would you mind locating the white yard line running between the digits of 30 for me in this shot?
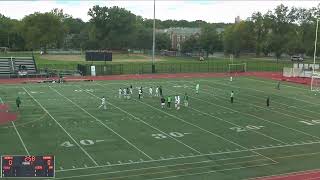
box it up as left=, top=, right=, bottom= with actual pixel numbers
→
left=81, top=83, right=201, bottom=154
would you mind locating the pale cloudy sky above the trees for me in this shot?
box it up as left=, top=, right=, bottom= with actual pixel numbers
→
left=0, top=0, right=319, bottom=23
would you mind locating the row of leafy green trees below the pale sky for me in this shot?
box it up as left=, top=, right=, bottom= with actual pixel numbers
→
left=0, top=4, right=320, bottom=58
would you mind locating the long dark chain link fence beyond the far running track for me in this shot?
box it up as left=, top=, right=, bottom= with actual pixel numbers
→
left=77, top=61, right=292, bottom=76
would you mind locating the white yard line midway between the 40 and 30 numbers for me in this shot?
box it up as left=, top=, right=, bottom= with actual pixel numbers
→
left=49, top=86, right=153, bottom=159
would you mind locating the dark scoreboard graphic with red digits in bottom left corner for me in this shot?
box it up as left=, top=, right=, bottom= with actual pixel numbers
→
left=1, top=155, right=55, bottom=178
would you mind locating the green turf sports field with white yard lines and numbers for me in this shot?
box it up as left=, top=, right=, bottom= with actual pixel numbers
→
left=0, top=77, right=320, bottom=180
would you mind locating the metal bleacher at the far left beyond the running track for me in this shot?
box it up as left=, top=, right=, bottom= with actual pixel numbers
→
left=0, top=57, right=37, bottom=77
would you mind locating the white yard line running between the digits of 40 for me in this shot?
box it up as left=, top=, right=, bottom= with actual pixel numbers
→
left=23, top=87, right=99, bottom=166
